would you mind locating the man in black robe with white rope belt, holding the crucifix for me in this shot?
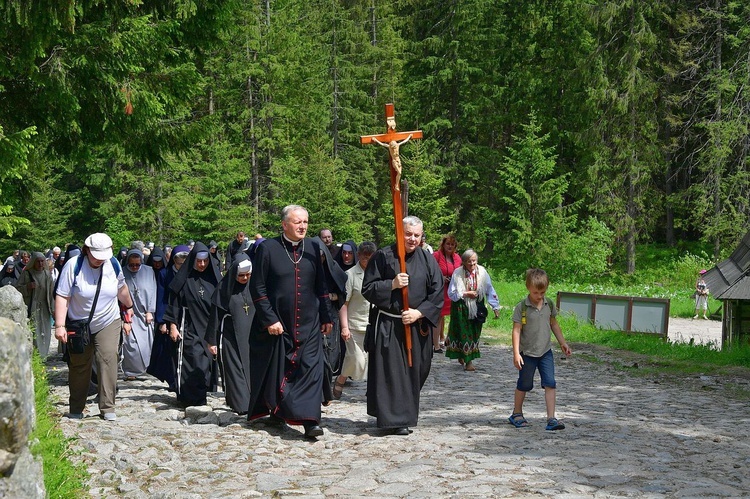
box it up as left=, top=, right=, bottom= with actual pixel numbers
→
left=362, top=217, right=443, bottom=435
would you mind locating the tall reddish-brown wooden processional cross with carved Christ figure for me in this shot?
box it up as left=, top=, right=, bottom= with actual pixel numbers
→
left=360, top=104, right=422, bottom=367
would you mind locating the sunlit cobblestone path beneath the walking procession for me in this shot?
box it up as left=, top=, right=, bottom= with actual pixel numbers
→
left=49, top=336, right=750, bottom=499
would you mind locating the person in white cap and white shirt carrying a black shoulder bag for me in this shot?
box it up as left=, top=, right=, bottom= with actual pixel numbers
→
left=55, top=233, right=133, bottom=421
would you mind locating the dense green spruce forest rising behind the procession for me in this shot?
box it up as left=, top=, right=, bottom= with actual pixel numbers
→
left=0, top=0, right=750, bottom=276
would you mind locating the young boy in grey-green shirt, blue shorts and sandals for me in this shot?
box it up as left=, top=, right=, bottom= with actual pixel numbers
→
left=508, top=269, right=572, bottom=430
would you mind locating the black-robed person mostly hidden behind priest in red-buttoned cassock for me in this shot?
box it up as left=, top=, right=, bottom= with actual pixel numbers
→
left=312, top=236, right=347, bottom=405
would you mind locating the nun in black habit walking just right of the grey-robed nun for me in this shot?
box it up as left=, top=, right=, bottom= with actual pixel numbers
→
left=164, top=242, right=221, bottom=405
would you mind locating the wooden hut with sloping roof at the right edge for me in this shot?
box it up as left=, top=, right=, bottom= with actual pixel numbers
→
left=703, top=232, right=750, bottom=345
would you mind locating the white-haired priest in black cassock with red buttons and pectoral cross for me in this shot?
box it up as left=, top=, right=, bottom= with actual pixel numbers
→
left=247, top=205, right=334, bottom=438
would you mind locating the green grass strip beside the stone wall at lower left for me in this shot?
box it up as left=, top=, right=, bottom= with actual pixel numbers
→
left=31, top=352, right=88, bottom=499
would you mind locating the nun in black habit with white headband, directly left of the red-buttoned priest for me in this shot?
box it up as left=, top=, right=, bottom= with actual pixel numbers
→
left=206, top=253, right=255, bottom=414
